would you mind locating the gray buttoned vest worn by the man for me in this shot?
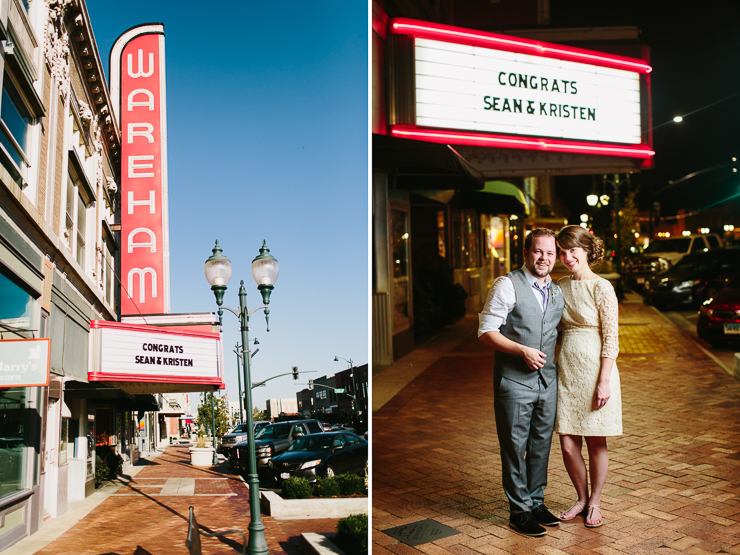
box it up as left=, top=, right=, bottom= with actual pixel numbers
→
left=493, top=268, right=565, bottom=387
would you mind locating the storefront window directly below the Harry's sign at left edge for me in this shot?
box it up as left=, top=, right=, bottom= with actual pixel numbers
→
left=0, top=387, right=33, bottom=498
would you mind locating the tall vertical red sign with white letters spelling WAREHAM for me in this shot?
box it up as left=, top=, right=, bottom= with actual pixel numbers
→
left=110, top=24, right=170, bottom=315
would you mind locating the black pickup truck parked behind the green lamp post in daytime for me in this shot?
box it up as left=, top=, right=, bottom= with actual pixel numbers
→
left=229, top=420, right=324, bottom=480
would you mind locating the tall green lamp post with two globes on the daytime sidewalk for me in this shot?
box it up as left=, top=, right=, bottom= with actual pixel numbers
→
left=205, top=241, right=278, bottom=555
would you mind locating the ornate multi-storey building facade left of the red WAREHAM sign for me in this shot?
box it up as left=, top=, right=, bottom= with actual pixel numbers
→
left=0, top=0, right=123, bottom=550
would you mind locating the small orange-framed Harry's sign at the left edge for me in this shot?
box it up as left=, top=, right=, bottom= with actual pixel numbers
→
left=0, top=338, right=51, bottom=389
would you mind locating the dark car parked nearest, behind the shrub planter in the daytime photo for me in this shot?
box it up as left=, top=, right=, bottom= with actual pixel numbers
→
left=271, top=431, right=368, bottom=482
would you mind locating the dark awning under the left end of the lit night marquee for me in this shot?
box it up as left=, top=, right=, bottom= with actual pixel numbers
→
left=373, top=134, right=483, bottom=190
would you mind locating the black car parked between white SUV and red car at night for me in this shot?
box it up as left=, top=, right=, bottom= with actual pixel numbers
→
left=643, top=249, right=740, bottom=306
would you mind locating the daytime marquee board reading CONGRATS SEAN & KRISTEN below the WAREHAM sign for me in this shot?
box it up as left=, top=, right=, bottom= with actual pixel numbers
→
left=88, top=320, right=223, bottom=386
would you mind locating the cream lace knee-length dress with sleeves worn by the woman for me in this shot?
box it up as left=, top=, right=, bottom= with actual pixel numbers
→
left=555, top=277, right=622, bottom=436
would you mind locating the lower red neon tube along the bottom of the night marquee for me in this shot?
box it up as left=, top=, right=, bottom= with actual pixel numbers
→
left=391, top=125, right=655, bottom=160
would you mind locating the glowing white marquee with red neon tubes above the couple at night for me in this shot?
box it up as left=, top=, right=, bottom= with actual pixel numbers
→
left=390, top=19, right=654, bottom=159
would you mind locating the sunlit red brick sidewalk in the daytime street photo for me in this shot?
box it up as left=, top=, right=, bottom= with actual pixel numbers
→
left=18, top=446, right=337, bottom=555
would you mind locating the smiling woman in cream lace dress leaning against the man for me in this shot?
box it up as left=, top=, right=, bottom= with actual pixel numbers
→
left=555, top=225, right=622, bottom=528
